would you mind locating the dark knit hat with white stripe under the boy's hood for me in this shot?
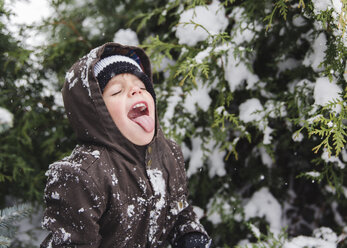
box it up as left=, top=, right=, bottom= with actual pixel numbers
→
left=94, top=51, right=156, bottom=102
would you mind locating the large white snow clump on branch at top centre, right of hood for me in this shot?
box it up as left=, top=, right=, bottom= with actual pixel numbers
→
left=176, top=0, right=228, bottom=46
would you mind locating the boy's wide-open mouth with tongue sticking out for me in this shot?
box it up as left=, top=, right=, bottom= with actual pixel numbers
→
left=128, top=102, right=154, bottom=133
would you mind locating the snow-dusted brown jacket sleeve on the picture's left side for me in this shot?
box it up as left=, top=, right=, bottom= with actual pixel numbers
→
left=41, top=162, right=105, bottom=248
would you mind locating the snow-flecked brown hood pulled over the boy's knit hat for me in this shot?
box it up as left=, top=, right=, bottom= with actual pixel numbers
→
left=62, top=43, right=159, bottom=158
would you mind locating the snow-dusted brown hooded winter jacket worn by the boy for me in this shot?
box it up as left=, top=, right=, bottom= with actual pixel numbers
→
left=41, top=43, right=206, bottom=248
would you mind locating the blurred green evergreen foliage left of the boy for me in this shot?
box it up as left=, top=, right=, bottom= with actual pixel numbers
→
left=0, top=1, right=73, bottom=204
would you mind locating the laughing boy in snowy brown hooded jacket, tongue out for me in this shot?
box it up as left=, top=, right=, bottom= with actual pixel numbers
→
left=41, top=43, right=210, bottom=248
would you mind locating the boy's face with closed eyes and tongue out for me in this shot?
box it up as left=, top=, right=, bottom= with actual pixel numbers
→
left=102, top=73, right=155, bottom=146
